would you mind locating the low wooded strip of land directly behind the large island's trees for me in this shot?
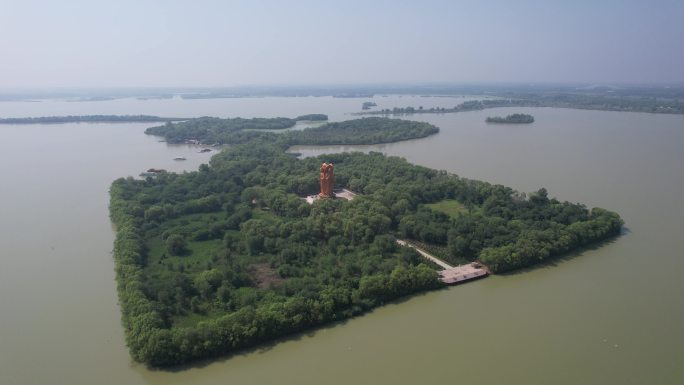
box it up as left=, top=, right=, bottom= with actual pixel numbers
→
left=145, top=115, right=439, bottom=146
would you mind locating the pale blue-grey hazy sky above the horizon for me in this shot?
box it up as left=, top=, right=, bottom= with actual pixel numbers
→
left=0, top=0, right=684, bottom=88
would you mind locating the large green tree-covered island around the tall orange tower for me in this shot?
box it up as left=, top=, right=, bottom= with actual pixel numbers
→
left=110, top=118, right=623, bottom=367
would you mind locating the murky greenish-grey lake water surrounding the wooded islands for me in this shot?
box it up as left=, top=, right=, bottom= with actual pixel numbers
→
left=0, top=96, right=684, bottom=385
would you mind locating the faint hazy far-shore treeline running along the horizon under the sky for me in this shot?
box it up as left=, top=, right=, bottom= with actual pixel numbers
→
left=0, top=83, right=684, bottom=102
